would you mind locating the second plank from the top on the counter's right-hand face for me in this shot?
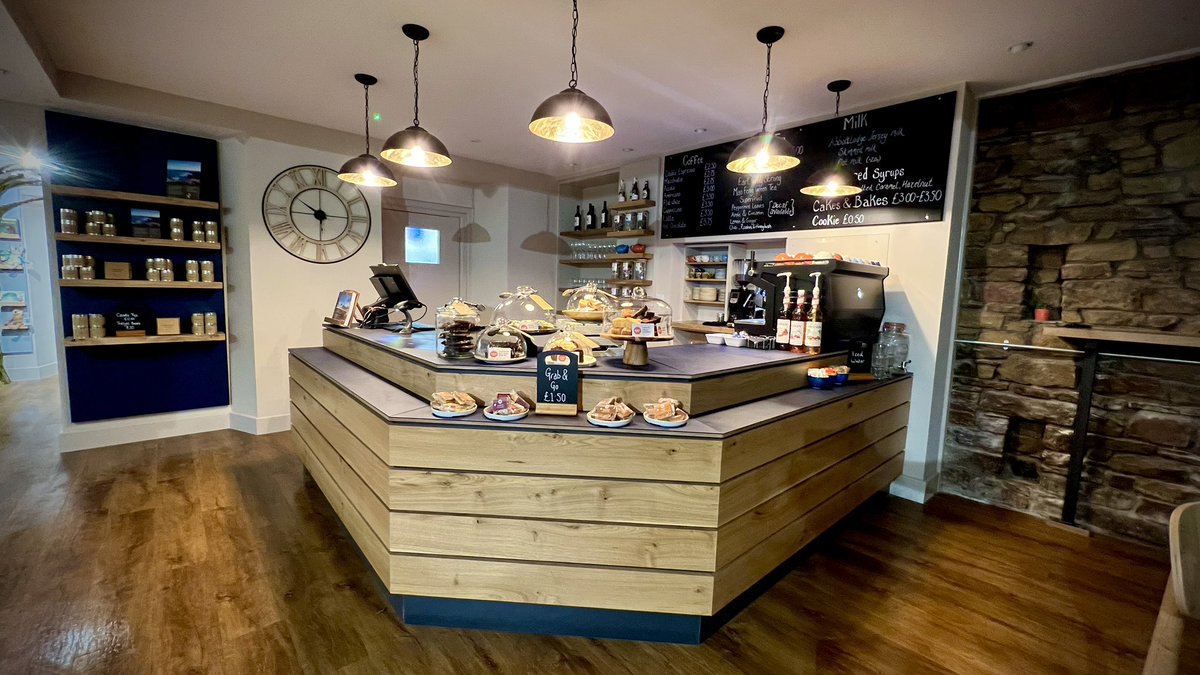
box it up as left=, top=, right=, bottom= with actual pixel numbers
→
left=720, top=404, right=908, bottom=524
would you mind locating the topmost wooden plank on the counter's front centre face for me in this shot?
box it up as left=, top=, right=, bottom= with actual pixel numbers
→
left=390, top=426, right=721, bottom=483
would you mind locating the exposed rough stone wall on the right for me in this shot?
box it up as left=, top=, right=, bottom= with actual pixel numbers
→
left=942, top=59, right=1200, bottom=543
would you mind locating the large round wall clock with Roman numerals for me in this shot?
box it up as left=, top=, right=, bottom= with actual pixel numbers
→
left=263, top=165, right=371, bottom=264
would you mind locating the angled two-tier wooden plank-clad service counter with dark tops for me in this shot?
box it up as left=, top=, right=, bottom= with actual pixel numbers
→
left=289, top=331, right=911, bottom=641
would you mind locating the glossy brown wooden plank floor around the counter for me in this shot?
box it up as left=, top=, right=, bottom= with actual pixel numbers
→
left=0, top=374, right=1200, bottom=674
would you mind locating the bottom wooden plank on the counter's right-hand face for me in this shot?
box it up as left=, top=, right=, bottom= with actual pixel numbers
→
left=712, top=454, right=904, bottom=613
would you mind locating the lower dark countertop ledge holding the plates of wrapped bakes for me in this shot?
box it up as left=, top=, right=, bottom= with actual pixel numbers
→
left=289, top=343, right=911, bottom=440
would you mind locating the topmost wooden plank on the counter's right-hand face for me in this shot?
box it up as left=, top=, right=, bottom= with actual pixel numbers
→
left=721, top=377, right=912, bottom=480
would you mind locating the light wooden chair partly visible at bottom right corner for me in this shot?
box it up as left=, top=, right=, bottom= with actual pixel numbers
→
left=1141, top=502, right=1200, bottom=675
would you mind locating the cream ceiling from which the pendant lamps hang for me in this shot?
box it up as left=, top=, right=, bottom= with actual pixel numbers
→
left=0, top=0, right=1200, bottom=177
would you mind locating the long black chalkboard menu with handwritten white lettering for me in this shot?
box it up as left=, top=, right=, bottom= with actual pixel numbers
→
left=662, top=91, right=955, bottom=239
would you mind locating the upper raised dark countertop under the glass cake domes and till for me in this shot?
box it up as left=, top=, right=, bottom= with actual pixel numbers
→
left=326, top=328, right=845, bottom=381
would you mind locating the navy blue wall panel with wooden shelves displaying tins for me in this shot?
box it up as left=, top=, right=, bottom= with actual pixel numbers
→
left=46, top=112, right=229, bottom=423
